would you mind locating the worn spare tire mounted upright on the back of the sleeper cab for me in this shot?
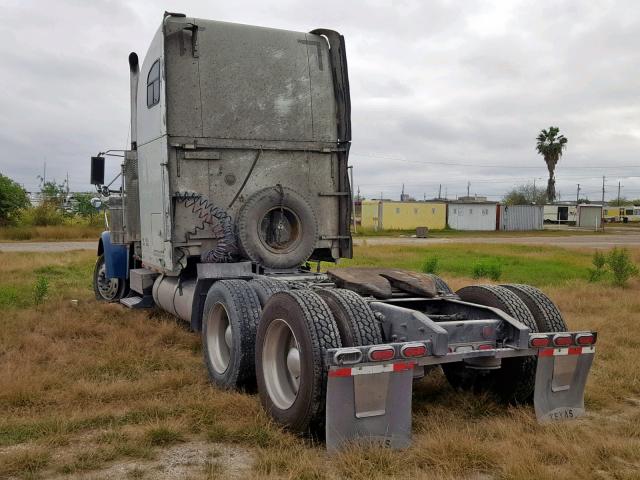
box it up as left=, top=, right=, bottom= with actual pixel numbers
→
left=237, top=185, right=318, bottom=268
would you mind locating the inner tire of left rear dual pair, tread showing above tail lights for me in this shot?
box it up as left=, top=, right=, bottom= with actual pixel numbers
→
left=316, top=288, right=383, bottom=347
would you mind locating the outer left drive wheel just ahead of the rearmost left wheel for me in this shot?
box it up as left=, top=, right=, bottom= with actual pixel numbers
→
left=202, top=280, right=260, bottom=390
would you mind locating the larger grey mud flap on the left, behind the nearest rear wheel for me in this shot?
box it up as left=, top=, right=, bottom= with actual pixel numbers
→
left=326, top=363, right=413, bottom=451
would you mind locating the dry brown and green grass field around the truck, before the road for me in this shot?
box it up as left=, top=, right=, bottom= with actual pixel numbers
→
left=0, top=245, right=640, bottom=479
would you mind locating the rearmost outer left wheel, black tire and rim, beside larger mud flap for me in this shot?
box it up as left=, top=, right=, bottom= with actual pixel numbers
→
left=256, top=290, right=342, bottom=432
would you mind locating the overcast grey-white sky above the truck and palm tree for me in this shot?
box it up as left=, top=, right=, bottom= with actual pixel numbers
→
left=0, top=0, right=640, bottom=200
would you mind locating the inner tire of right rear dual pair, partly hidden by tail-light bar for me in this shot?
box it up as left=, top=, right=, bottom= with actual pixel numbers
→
left=442, top=285, right=538, bottom=403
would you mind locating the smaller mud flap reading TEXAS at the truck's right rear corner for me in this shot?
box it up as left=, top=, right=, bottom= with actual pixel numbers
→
left=533, top=346, right=595, bottom=423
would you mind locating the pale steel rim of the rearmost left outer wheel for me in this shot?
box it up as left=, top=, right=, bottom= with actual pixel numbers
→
left=262, top=318, right=301, bottom=410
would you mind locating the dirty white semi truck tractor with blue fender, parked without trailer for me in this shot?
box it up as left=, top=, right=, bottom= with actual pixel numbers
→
left=91, top=13, right=596, bottom=449
